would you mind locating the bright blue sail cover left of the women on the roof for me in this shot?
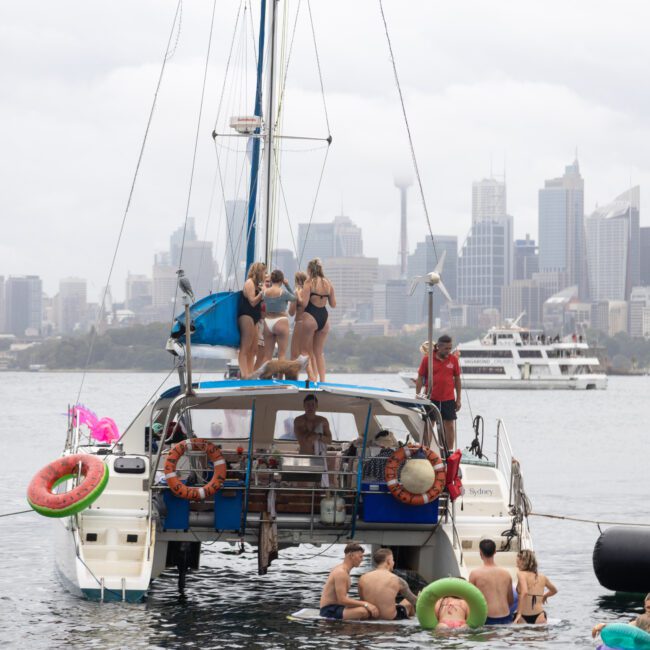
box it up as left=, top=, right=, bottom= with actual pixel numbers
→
left=171, top=291, right=241, bottom=348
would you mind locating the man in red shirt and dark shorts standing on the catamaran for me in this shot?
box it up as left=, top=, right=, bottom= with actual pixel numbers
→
left=415, top=334, right=461, bottom=450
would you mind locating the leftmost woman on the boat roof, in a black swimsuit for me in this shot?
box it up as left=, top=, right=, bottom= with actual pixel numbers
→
left=237, top=262, right=266, bottom=379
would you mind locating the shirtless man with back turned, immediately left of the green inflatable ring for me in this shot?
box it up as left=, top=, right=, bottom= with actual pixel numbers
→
left=359, top=548, right=417, bottom=621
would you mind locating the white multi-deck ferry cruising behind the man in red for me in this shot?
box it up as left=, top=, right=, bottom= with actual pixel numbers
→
left=400, top=325, right=607, bottom=390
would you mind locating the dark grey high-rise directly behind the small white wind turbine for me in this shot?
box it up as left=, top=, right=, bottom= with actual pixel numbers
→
left=406, top=235, right=458, bottom=323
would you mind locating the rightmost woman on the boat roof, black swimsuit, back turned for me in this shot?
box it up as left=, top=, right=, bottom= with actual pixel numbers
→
left=300, top=258, right=336, bottom=381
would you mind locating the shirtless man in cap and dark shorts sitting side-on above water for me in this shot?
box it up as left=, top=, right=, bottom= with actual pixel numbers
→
left=320, top=542, right=379, bottom=621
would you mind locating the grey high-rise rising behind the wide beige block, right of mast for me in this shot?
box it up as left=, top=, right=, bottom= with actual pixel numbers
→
left=298, top=216, right=363, bottom=267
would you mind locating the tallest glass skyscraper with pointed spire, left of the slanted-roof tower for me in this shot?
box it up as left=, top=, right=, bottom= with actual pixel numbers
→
left=539, top=160, right=587, bottom=296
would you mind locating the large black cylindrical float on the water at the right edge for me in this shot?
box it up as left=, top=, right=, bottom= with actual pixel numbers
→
left=593, top=526, right=650, bottom=594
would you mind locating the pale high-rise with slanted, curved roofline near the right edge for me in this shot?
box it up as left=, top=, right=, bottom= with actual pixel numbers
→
left=585, top=187, right=640, bottom=301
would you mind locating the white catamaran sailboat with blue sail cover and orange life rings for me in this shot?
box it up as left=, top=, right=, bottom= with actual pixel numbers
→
left=28, top=0, right=532, bottom=602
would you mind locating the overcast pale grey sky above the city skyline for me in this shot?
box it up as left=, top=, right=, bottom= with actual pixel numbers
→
left=0, top=0, right=650, bottom=300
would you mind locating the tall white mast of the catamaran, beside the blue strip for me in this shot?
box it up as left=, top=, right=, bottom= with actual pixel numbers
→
left=262, top=0, right=279, bottom=264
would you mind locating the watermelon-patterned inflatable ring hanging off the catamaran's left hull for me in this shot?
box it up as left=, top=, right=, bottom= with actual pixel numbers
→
left=27, top=454, right=109, bottom=517
